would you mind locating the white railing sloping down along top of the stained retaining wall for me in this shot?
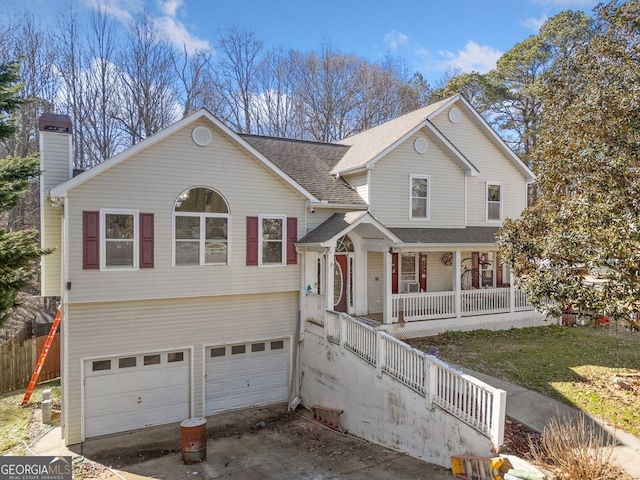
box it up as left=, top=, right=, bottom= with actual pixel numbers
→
left=325, top=312, right=507, bottom=449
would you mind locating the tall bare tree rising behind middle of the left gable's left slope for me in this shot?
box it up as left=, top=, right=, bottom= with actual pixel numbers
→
left=117, top=13, right=179, bottom=145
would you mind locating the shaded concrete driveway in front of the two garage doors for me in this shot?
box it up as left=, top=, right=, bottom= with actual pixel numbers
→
left=35, top=409, right=453, bottom=480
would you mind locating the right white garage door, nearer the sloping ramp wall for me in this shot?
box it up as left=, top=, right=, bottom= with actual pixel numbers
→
left=205, top=340, right=289, bottom=415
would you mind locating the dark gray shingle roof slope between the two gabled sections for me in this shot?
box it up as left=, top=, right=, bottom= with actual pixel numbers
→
left=239, top=134, right=367, bottom=206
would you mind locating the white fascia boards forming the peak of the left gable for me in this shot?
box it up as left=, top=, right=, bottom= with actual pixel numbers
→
left=49, top=108, right=319, bottom=202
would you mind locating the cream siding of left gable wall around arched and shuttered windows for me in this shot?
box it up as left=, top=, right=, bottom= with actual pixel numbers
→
left=65, top=122, right=305, bottom=302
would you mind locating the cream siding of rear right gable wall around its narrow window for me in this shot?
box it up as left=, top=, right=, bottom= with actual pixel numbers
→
left=432, top=109, right=527, bottom=226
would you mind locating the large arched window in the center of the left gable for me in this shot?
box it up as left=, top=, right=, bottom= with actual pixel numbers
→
left=173, top=187, right=230, bottom=266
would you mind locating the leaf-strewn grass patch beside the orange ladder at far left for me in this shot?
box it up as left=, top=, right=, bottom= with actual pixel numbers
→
left=0, top=380, right=60, bottom=455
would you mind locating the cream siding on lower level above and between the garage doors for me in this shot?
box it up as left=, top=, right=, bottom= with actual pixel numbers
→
left=65, top=290, right=300, bottom=443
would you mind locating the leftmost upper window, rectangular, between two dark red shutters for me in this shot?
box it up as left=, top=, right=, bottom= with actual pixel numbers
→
left=100, top=210, right=138, bottom=268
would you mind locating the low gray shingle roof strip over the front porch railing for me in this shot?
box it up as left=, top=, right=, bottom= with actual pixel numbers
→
left=389, top=227, right=498, bottom=245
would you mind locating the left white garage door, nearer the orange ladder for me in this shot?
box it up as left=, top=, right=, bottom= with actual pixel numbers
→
left=84, top=350, right=190, bottom=438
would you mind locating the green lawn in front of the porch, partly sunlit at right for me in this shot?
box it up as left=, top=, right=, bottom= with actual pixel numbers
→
left=410, top=324, right=640, bottom=437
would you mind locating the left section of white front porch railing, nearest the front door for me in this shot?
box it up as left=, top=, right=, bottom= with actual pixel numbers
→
left=391, top=292, right=456, bottom=322
